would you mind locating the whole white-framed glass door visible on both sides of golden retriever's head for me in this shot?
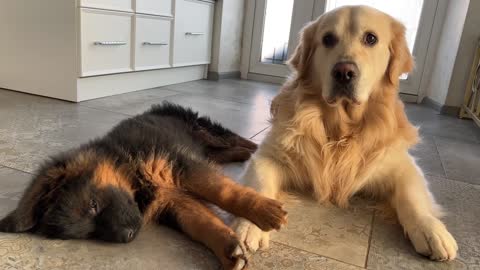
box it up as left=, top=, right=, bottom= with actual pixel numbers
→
left=249, top=0, right=438, bottom=95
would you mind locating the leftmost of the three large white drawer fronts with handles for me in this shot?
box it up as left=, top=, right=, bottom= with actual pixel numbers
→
left=80, top=9, right=132, bottom=76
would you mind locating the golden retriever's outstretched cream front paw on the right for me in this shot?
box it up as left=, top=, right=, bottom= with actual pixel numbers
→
left=406, top=216, right=458, bottom=261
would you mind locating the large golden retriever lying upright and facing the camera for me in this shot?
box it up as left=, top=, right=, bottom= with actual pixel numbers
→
left=234, top=6, right=458, bottom=261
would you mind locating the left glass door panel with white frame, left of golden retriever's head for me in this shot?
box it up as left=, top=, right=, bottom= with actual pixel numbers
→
left=249, top=0, right=314, bottom=77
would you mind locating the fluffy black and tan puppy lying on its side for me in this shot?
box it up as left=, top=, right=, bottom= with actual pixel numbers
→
left=0, top=103, right=286, bottom=269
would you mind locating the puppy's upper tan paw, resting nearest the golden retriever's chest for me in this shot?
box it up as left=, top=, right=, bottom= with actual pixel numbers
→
left=247, top=196, right=287, bottom=232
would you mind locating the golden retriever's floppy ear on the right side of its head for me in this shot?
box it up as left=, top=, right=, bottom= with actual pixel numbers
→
left=387, top=19, right=414, bottom=84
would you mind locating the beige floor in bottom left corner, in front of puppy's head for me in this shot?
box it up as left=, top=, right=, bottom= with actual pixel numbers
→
left=0, top=227, right=219, bottom=270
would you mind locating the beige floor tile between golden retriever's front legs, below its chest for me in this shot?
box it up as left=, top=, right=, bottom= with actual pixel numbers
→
left=272, top=195, right=373, bottom=267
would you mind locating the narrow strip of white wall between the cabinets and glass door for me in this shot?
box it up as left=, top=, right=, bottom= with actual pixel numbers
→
left=210, top=0, right=245, bottom=74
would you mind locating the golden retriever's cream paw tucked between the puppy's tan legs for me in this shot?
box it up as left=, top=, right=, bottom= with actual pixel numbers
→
left=232, top=218, right=270, bottom=254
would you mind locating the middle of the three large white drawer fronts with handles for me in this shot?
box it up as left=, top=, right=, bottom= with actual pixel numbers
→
left=135, top=15, right=171, bottom=70
